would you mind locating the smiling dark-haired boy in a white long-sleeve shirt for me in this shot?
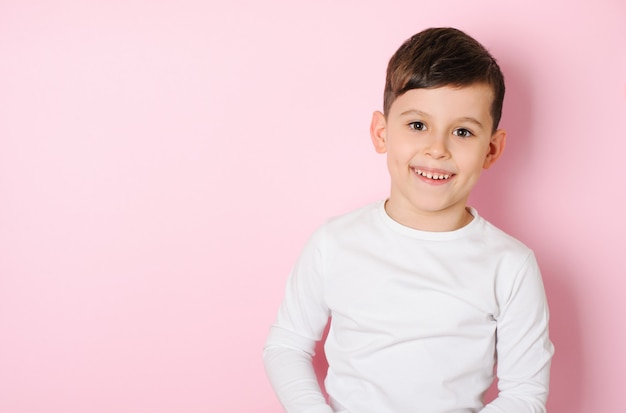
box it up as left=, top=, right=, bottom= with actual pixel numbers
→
left=264, top=28, right=553, bottom=413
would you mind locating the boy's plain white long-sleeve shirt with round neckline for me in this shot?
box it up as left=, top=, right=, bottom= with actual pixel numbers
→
left=264, top=202, right=553, bottom=413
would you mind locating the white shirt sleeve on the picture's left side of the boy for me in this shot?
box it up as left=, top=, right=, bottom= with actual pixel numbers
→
left=263, top=230, right=333, bottom=413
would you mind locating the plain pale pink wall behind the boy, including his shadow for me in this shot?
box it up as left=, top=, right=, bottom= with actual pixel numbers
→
left=0, top=0, right=626, bottom=413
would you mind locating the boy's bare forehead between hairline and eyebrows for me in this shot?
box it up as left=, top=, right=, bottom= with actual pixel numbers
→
left=389, top=83, right=493, bottom=120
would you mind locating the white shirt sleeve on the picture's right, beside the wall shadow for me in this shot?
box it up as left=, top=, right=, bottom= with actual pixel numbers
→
left=480, top=253, right=554, bottom=413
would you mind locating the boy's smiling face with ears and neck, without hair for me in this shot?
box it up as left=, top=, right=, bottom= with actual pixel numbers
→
left=370, top=84, right=506, bottom=231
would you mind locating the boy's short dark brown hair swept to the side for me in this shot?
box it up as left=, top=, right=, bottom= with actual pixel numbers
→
left=383, top=27, right=504, bottom=131
